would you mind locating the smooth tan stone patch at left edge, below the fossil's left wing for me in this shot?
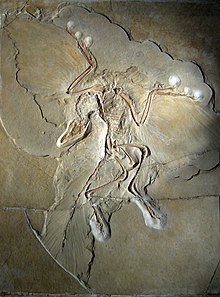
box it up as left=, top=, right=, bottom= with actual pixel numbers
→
left=0, top=128, right=57, bottom=209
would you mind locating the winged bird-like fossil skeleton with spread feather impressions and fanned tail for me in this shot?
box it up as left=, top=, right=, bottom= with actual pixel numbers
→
left=1, top=6, right=220, bottom=288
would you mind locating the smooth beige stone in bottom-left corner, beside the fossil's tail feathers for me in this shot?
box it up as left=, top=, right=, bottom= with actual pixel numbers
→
left=0, top=210, right=85, bottom=294
